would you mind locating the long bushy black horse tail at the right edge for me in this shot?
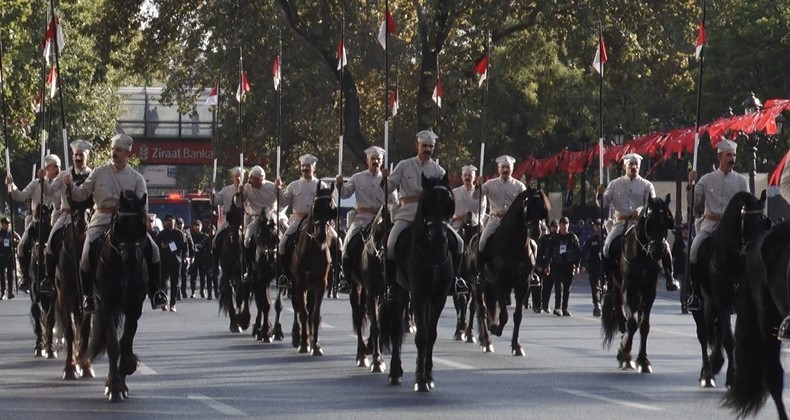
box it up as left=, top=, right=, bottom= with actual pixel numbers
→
left=724, top=244, right=779, bottom=417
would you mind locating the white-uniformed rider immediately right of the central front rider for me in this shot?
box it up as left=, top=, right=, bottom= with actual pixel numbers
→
left=474, top=155, right=527, bottom=283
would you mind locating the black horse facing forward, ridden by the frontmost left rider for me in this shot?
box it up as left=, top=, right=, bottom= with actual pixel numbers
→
left=88, top=190, right=151, bottom=402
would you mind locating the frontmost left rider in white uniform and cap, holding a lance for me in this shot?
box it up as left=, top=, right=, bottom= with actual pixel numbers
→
left=63, top=134, right=167, bottom=313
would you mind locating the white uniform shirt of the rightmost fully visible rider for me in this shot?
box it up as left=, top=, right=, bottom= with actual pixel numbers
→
left=694, top=169, right=749, bottom=233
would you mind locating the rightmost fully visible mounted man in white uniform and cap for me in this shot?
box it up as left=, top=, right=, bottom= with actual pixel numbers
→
left=686, top=139, right=749, bottom=311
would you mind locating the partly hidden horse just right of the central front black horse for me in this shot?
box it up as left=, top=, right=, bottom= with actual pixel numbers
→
left=453, top=212, right=485, bottom=343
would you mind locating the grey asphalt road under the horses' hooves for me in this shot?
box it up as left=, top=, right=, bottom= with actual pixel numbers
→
left=0, top=277, right=788, bottom=420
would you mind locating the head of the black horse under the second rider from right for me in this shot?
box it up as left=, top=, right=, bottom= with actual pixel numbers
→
left=636, top=194, right=674, bottom=260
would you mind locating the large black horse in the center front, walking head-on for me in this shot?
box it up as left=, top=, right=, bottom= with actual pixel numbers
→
left=381, top=174, right=455, bottom=392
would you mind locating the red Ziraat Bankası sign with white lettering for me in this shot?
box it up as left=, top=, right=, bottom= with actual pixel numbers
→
left=132, top=140, right=214, bottom=165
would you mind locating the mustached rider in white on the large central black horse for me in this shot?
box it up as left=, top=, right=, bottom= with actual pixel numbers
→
left=382, top=130, right=464, bottom=288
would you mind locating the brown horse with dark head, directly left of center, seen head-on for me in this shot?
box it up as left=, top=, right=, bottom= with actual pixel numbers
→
left=291, top=182, right=337, bottom=356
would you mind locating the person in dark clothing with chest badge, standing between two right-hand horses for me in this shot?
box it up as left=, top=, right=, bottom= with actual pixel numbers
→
left=546, top=217, right=581, bottom=316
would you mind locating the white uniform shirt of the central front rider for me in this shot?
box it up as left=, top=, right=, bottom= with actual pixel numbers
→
left=387, top=156, right=445, bottom=222
